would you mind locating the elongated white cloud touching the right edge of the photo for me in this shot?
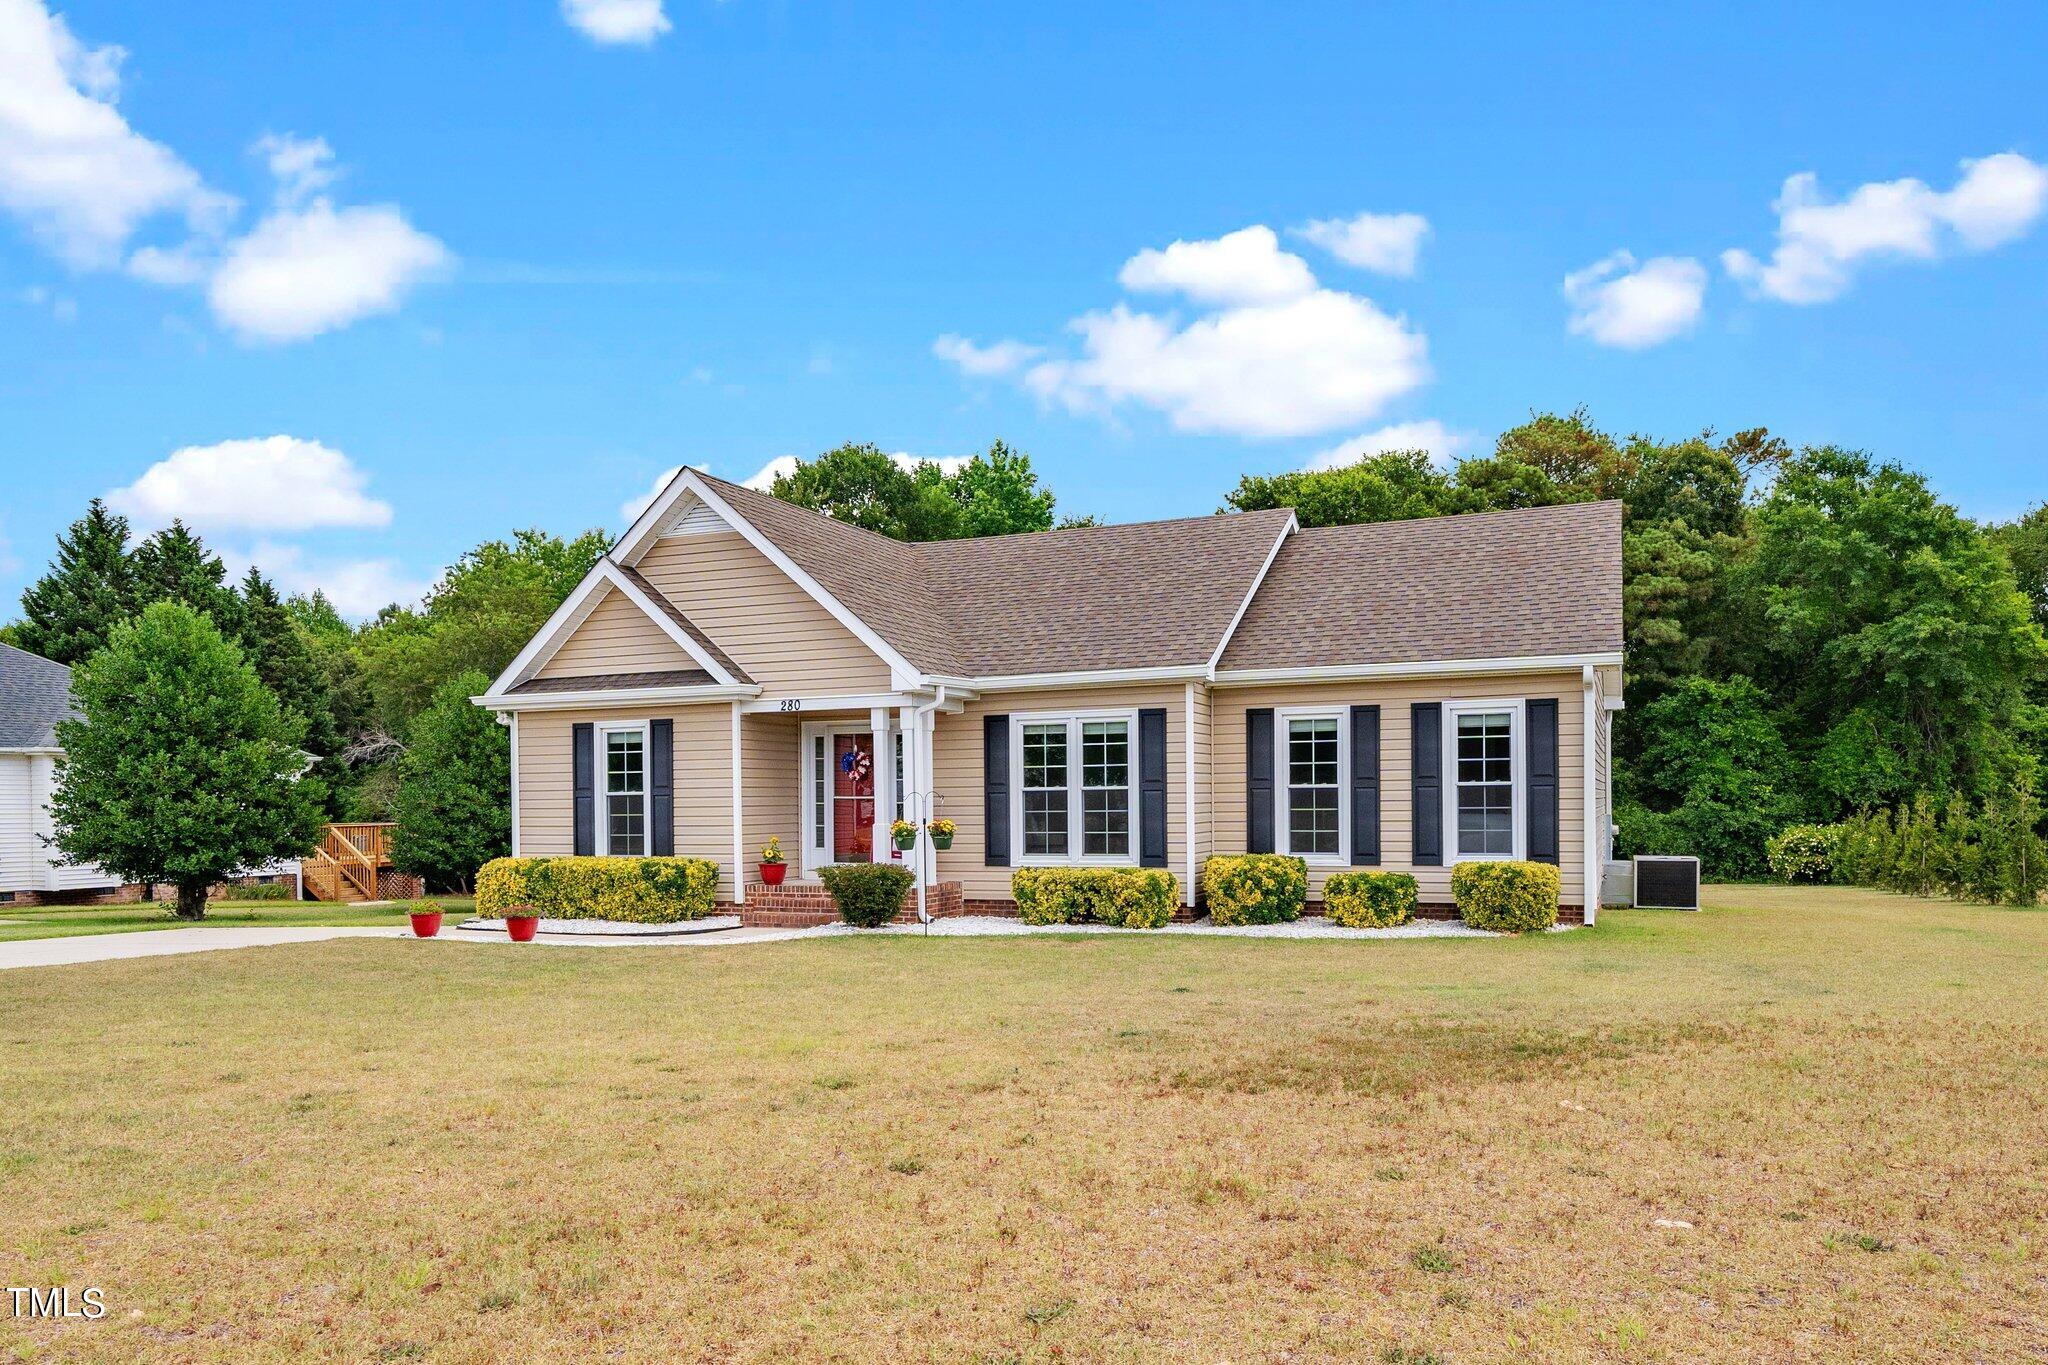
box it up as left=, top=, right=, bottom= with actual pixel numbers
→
left=1720, top=151, right=2048, bottom=303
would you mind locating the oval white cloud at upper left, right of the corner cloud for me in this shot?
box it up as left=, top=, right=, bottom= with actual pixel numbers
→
left=207, top=199, right=453, bottom=342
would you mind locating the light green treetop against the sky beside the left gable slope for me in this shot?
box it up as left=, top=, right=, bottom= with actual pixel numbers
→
left=356, top=530, right=610, bottom=735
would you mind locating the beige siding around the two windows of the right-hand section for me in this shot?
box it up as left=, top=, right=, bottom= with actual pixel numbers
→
left=1210, top=673, right=1585, bottom=905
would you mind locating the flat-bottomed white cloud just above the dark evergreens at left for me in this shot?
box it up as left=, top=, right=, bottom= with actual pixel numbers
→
left=106, top=436, right=391, bottom=530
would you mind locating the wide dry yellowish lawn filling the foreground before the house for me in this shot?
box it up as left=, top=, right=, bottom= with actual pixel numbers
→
left=0, top=886, right=2048, bottom=1365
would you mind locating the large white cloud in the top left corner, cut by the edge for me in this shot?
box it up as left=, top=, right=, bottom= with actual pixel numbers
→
left=0, top=0, right=233, bottom=268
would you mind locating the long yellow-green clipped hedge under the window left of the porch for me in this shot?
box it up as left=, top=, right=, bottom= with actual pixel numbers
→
left=477, top=857, right=719, bottom=925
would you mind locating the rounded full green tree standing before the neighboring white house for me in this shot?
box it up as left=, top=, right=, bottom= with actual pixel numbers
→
left=51, top=602, right=322, bottom=919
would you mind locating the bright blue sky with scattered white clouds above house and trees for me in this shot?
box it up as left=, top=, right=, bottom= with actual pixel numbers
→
left=0, top=0, right=2048, bottom=614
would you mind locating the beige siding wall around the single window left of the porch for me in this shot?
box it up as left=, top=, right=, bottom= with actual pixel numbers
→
left=518, top=704, right=735, bottom=900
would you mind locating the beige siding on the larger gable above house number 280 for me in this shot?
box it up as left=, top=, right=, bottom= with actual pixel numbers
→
left=635, top=532, right=889, bottom=696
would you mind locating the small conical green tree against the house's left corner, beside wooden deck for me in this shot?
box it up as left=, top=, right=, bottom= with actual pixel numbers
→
left=391, top=671, right=512, bottom=892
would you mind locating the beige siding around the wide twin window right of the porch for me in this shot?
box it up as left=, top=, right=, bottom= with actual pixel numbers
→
left=932, top=684, right=1188, bottom=900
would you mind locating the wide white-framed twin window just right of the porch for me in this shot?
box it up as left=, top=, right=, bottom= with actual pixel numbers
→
left=1012, top=712, right=1137, bottom=862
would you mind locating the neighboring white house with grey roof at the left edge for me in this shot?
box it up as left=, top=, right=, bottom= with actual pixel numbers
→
left=0, top=645, right=121, bottom=902
